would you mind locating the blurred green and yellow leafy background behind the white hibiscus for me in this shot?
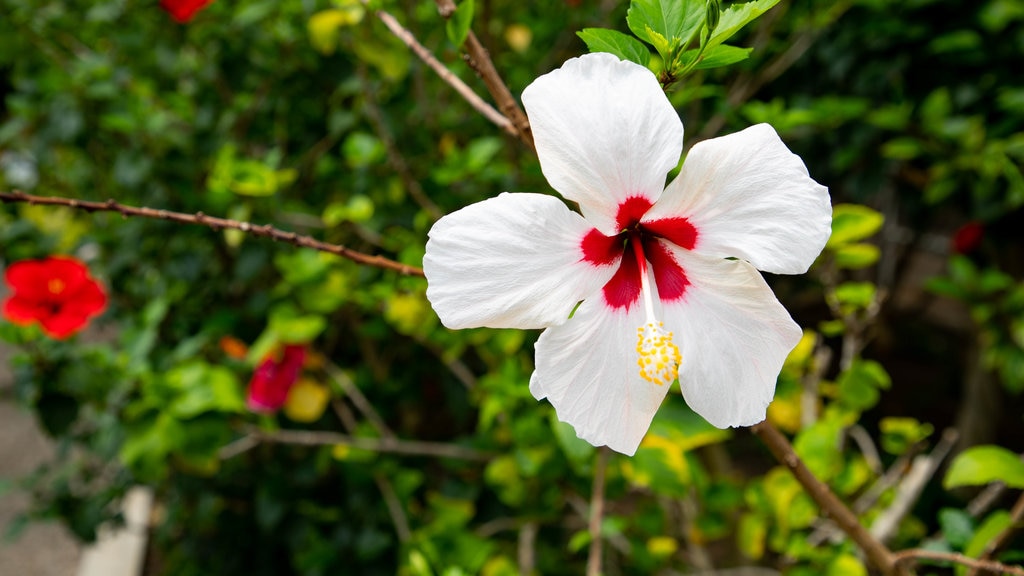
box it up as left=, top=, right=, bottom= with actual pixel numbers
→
left=0, top=0, right=1024, bottom=576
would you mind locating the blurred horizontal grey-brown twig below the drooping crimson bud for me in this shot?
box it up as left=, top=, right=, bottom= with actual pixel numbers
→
left=247, top=428, right=493, bottom=460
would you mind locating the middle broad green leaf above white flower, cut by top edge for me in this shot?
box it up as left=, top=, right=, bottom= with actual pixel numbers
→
left=626, top=0, right=705, bottom=61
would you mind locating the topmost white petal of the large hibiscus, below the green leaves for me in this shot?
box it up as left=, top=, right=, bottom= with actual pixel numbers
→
left=522, top=53, right=683, bottom=234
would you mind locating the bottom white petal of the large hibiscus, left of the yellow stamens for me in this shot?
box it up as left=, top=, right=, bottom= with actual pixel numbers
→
left=529, top=297, right=669, bottom=455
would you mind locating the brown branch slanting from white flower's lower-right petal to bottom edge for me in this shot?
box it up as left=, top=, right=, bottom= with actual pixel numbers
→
left=751, top=420, right=902, bottom=575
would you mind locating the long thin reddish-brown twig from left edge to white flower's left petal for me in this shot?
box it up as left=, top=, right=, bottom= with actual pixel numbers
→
left=0, top=191, right=423, bottom=276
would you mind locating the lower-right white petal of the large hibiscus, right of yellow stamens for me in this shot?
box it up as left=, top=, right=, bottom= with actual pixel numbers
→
left=664, top=249, right=801, bottom=428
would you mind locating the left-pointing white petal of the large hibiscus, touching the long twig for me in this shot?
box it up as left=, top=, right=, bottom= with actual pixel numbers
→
left=423, top=193, right=617, bottom=328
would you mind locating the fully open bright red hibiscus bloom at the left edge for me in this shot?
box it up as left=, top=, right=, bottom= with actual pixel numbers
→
left=3, top=256, right=106, bottom=339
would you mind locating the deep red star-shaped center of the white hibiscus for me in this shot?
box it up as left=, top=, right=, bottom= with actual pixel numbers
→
left=580, top=196, right=697, bottom=311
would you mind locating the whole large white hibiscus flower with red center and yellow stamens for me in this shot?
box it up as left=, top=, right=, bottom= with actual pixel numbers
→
left=423, top=53, right=831, bottom=454
